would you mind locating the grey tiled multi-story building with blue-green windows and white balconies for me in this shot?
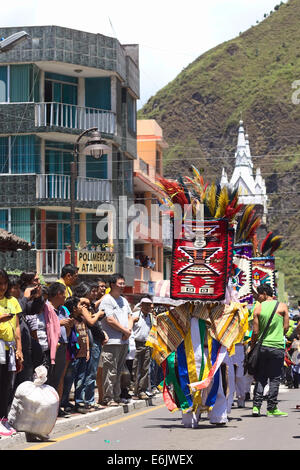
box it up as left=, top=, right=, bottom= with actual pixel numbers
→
left=0, top=26, right=139, bottom=285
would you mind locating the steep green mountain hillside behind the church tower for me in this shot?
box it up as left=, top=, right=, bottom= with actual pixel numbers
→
left=138, top=0, right=300, bottom=299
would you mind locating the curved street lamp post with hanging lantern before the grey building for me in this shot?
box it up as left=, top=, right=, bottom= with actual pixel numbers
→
left=70, top=127, right=110, bottom=266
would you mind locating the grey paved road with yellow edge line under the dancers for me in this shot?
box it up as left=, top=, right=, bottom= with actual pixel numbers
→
left=8, top=387, right=300, bottom=452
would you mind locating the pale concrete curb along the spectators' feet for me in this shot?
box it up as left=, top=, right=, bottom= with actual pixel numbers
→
left=0, top=394, right=163, bottom=450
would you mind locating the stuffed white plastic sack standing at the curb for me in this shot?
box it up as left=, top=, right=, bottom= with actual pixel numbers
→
left=8, top=366, right=59, bottom=438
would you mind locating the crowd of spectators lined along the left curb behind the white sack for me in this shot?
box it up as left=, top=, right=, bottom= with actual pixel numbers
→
left=0, top=264, right=163, bottom=437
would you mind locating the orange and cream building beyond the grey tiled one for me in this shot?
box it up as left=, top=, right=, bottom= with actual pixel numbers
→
left=123, top=119, right=172, bottom=302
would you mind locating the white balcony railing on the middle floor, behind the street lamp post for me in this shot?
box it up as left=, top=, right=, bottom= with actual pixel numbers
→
left=36, top=174, right=111, bottom=202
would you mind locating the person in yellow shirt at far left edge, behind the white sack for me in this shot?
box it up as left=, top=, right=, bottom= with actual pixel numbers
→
left=0, top=269, right=23, bottom=436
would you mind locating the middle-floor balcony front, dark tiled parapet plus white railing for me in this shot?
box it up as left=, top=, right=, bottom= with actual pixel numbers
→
left=0, top=174, right=112, bottom=208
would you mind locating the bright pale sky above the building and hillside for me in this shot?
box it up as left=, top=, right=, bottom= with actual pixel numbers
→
left=0, top=0, right=286, bottom=109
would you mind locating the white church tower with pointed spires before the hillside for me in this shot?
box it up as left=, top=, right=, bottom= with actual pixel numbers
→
left=220, top=121, right=268, bottom=224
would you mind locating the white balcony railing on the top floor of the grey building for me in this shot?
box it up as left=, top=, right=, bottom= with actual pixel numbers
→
left=35, top=102, right=116, bottom=134
